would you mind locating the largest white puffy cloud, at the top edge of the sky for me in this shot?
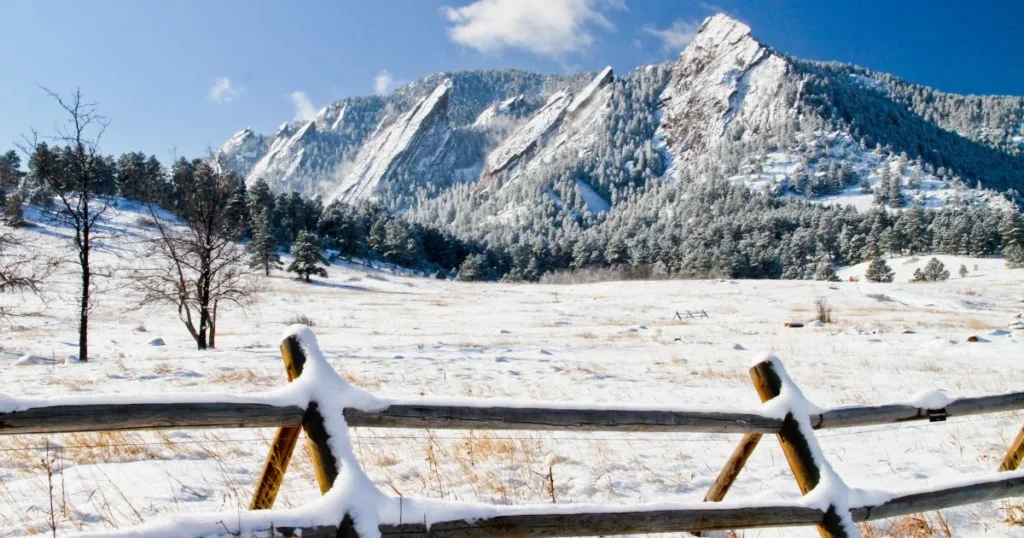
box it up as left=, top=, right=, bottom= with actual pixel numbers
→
left=443, top=0, right=626, bottom=57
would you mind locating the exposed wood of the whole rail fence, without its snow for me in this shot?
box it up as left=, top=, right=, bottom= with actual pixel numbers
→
left=0, top=325, right=1024, bottom=538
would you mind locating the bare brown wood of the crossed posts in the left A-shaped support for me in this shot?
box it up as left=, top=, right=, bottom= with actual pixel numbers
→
left=250, top=335, right=338, bottom=510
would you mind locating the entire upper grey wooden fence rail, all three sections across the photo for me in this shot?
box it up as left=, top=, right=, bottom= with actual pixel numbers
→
left=8, top=391, right=1024, bottom=434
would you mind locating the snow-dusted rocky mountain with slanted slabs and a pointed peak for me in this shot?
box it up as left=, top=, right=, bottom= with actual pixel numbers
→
left=217, top=14, right=1024, bottom=216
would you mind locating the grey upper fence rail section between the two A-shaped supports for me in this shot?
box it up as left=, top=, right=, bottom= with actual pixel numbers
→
left=345, top=404, right=782, bottom=433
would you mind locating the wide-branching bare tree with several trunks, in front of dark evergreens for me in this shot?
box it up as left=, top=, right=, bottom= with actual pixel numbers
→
left=133, top=159, right=261, bottom=349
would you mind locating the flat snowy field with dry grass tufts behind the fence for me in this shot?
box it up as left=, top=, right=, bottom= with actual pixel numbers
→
left=0, top=203, right=1024, bottom=537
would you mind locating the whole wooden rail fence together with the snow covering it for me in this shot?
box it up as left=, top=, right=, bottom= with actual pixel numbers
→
left=0, top=327, right=1024, bottom=538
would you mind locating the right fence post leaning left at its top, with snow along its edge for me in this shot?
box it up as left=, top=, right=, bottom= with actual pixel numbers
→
left=751, top=358, right=851, bottom=538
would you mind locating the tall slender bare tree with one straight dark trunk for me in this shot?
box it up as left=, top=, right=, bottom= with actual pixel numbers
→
left=22, top=87, right=108, bottom=361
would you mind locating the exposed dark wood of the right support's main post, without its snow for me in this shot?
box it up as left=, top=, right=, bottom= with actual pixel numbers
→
left=751, top=361, right=849, bottom=538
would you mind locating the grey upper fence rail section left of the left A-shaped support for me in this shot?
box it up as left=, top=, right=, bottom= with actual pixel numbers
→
left=0, top=403, right=305, bottom=434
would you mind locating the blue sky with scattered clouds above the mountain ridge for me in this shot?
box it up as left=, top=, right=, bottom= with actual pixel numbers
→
left=0, top=0, right=1024, bottom=161
